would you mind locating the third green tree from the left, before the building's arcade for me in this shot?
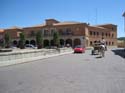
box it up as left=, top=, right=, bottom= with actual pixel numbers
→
left=36, top=31, right=43, bottom=49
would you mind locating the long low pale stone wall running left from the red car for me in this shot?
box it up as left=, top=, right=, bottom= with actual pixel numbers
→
left=0, top=48, right=72, bottom=66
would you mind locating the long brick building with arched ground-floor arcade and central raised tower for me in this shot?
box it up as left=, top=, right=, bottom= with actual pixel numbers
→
left=0, top=19, right=117, bottom=47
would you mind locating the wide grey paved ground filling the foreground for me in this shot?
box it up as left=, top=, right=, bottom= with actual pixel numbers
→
left=0, top=50, right=125, bottom=93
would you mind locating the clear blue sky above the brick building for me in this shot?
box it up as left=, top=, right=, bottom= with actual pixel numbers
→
left=0, top=0, right=125, bottom=37
